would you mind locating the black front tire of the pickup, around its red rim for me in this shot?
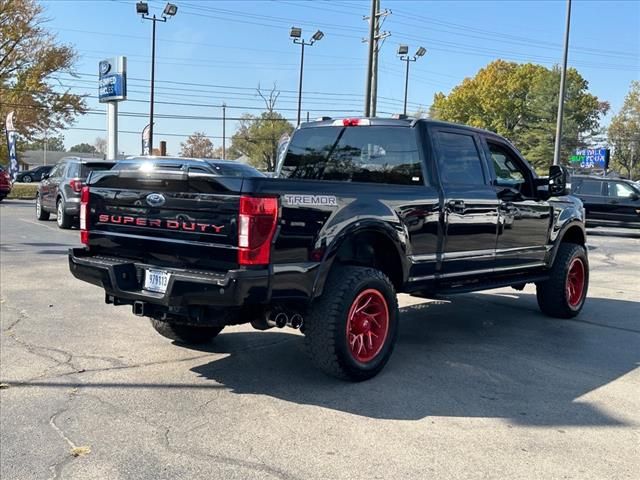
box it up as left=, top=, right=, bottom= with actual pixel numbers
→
left=536, top=243, right=589, bottom=318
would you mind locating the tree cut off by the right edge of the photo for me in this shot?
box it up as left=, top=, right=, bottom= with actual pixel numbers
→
left=607, top=80, right=640, bottom=179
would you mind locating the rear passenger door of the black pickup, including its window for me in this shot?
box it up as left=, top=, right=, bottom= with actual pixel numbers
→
left=431, top=127, right=499, bottom=278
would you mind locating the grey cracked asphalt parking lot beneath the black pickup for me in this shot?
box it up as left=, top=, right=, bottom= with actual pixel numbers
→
left=0, top=200, right=640, bottom=480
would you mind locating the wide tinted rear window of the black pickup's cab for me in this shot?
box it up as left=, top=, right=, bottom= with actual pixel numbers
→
left=280, top=126, right=424, bottom=185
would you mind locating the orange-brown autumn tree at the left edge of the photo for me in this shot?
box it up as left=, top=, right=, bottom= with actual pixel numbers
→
left=0, top=0, right=86, bottom=165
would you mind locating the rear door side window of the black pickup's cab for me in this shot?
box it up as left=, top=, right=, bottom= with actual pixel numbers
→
left=435, top=131, right=486, bottom=185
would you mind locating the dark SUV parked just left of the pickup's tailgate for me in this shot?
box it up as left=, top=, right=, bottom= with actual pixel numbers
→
left=36, top=157, right=115, bottom=228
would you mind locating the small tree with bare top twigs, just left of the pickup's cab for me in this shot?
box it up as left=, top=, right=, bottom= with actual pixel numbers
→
left=228, top=85, right=293, bottom=172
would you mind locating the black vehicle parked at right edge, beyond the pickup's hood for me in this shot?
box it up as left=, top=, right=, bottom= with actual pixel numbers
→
left=571, top=175, right=640, bottom=228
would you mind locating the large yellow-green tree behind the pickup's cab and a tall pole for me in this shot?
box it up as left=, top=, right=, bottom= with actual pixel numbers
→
left=430, top=60, right=609, bottom=170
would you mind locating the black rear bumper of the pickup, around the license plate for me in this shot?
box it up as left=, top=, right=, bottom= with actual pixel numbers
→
left=69, top=248, right=271, bottom=307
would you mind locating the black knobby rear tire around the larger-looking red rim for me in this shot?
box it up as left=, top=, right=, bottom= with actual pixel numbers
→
left=304, top=266, right=398, bottom=382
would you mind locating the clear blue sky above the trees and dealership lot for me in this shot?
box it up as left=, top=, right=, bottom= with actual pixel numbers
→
left=43, top=0, right=640, bottom=154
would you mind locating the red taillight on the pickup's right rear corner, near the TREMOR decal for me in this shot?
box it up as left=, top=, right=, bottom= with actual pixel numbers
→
left=238, top=195, right=278, bottom=265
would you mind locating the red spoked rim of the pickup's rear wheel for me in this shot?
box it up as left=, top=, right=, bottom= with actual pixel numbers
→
left=347, top=288, right=389, bottom=363
